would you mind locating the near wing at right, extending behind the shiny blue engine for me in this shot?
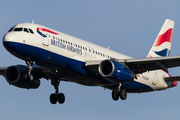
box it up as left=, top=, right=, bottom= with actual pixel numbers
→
left=85, top=56, right=180, bottom=74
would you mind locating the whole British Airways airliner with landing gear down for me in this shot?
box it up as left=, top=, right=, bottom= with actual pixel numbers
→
left=0, top=19, right=180, bottom=104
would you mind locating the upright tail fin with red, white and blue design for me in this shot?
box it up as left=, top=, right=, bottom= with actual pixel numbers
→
left=147, top=19, right=174, bottom=58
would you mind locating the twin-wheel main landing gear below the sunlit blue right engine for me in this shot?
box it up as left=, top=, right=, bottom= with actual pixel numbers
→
left=112, top=85, right=127, bottom=101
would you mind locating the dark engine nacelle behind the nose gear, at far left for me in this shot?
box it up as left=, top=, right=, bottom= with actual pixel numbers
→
left=4, top=65, right=40, bottom=89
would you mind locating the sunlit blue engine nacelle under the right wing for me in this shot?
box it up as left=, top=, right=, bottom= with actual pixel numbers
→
left=99, top=60, right=135, bottom=83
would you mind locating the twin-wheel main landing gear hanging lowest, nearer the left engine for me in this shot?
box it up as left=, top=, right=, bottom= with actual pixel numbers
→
left=50, top=80, right=65, bottom=104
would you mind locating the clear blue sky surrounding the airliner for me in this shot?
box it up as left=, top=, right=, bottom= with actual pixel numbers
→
left=0, top=0, right=180, bottom=120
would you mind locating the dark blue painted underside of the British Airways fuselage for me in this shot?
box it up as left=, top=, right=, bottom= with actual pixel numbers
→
left=3, top=42, right=153, bottom=92
